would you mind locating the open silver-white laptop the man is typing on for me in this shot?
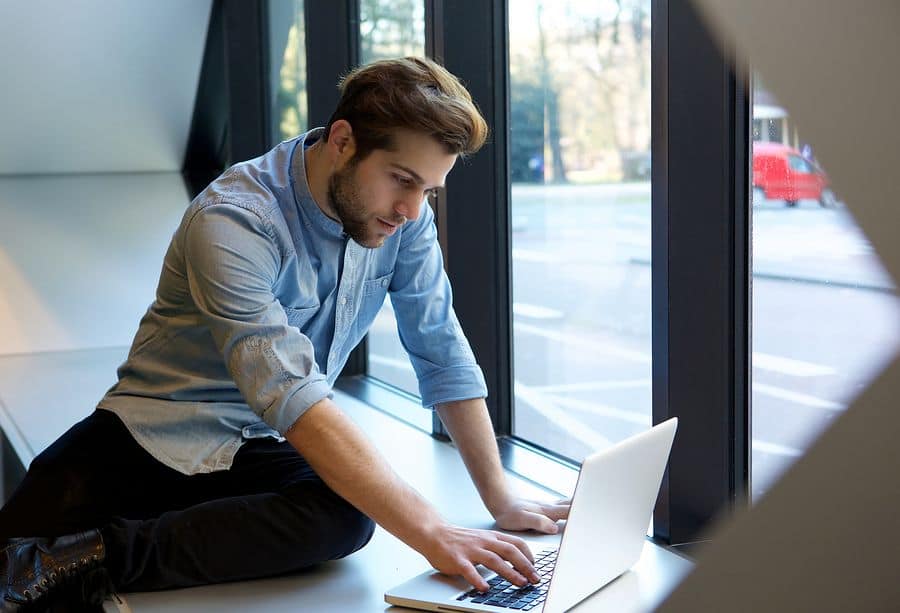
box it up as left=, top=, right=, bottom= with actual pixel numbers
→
left=384, top=418, right=678, bottom=613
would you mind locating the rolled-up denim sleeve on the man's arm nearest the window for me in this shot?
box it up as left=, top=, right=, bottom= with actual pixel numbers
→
left=390, top=205, right=487, bottom=407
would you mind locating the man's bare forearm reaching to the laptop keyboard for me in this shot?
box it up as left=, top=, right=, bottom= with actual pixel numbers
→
left=285, top=398, right=443, bottom=549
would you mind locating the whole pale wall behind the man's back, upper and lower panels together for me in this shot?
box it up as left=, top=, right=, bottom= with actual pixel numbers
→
left=0, top=0, right=212, bottom=356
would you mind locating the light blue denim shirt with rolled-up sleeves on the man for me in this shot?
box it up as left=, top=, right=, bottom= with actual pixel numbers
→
left=98, top=129, right=487, bottom=474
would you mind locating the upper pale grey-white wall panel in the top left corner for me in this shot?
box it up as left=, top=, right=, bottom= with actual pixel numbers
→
left=0, top=0, right=212, bottom=175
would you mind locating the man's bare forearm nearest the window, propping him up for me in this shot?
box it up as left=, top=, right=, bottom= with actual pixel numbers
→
left=437, top=398, right=510, bottom=516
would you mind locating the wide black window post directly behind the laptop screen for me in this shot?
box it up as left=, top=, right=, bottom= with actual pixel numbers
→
left=651, top=0, right=751, bottom=544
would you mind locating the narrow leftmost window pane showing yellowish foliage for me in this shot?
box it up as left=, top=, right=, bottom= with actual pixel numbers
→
left=269, top=0, right=307, bottom=142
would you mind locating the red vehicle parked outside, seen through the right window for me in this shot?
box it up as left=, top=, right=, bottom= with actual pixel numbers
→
left=753, top=142, right=837, bottom=207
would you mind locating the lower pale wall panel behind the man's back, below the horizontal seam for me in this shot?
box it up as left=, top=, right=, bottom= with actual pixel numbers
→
left=0, top=173, right=189, bottom=355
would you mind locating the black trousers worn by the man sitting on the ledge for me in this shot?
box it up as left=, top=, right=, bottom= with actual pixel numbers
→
left=0, top=410, right=374, bottom=592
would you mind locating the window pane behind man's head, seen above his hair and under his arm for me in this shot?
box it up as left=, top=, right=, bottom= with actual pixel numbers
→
left=359, top=0, right=431, bottom=432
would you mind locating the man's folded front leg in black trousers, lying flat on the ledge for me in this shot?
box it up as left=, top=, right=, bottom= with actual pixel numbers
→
left=102, top=481, right=374, bottom=592
